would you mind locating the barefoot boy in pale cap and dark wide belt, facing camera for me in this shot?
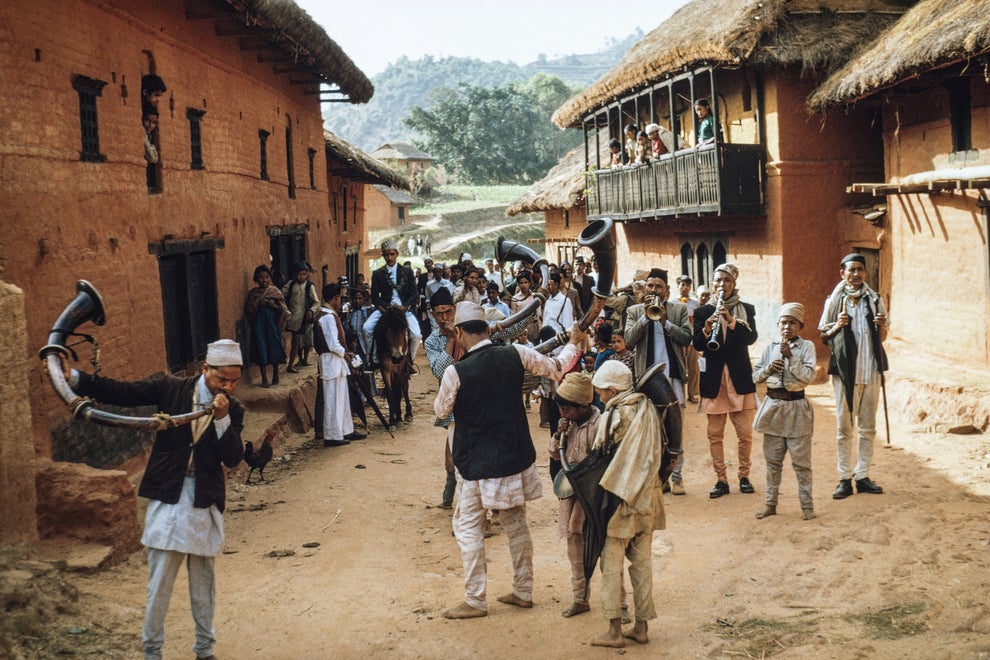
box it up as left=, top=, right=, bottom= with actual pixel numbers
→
left=753, top=303, right=815, bottom=520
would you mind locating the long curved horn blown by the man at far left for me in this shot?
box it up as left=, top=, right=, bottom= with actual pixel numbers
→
left=38, top=280, right=213, bottom=431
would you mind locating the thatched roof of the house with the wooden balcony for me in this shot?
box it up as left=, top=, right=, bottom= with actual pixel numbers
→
left=553, top=0, right=915, bottom=127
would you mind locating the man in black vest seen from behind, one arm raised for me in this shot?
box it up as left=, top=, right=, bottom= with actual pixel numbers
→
left=433, top=301, right=587, bottom=619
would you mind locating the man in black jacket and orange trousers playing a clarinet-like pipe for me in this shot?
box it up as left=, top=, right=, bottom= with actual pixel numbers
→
left=694, top=263, right=757, bottom=499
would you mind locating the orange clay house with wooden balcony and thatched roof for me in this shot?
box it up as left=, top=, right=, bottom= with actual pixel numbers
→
left=553, top=0, right=905, bottom=336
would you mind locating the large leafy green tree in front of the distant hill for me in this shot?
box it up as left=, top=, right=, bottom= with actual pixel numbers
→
left=405, top=74, right=581, bottom=184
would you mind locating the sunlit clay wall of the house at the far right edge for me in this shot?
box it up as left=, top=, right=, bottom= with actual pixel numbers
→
left=884, top=89, right=990, bottom=367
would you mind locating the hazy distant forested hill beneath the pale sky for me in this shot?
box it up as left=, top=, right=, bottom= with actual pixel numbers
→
left=323, top=30, right=643, bottom=153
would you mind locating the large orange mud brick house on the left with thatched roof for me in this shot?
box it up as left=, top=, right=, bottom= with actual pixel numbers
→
left=0, top=0, right=374, bottom=544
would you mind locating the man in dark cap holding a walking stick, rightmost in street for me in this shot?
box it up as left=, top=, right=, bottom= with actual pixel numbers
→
left=818, top=252, right=890, bottom=500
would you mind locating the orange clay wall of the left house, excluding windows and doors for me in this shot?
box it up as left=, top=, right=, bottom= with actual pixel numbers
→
left=0, top=0, right=342, bottom=455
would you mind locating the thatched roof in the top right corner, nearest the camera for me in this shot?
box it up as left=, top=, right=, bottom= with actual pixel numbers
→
left=809, top=0, right=990, bottom=111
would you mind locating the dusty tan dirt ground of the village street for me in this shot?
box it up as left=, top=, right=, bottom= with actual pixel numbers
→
left=0, top=359, right=990, bottom=659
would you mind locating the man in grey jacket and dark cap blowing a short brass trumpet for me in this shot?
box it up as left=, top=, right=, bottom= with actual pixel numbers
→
left=624, top=268, right=692, bottom=495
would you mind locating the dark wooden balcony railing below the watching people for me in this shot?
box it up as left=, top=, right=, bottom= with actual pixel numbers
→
left=587, top=144, right=766, bottom=220
